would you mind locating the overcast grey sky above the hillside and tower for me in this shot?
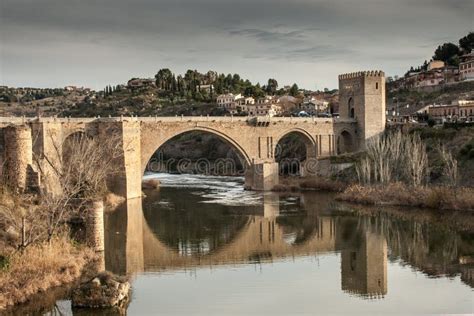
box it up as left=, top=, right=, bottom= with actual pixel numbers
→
left=0, top=0, right=474, bottom=89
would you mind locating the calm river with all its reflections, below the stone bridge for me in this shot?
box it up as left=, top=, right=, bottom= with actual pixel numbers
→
left=18, top=174, right=474, bottom=315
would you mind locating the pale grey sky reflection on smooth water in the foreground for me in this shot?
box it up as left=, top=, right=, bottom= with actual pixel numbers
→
left=128, top=254, right=473, bottom=315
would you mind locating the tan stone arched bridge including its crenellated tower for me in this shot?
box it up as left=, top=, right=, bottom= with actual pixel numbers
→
left=0, top=72, right=385, bottom=198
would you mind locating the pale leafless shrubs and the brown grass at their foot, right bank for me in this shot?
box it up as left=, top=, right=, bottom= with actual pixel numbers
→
left=337, top=131, right=474, bottom=211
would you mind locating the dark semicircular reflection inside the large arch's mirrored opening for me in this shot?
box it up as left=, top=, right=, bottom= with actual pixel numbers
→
left=143, top=188, right=248, bottom=255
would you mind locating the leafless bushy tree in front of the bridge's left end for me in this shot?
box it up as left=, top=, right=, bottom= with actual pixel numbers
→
left=35, top=133, right=122, bottom=241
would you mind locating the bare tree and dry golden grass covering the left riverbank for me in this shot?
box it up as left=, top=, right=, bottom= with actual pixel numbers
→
left=0, top=134, right=120, bottom=310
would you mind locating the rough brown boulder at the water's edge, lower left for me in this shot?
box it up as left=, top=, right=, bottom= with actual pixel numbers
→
left=71, top=272, right=130, bottom=308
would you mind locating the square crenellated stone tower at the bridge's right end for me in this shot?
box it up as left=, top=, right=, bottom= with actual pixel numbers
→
left=339, top=71, right=385, bottom=148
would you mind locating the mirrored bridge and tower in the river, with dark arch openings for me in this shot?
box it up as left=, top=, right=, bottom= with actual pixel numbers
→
left=105, top=188, right=387, bottom=297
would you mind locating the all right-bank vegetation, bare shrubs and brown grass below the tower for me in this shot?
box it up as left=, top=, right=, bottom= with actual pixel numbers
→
left=273, top=127, right=474, bottom=211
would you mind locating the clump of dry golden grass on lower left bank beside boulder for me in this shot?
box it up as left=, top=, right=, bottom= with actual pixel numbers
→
left=0, top=238, right=94, bottom=311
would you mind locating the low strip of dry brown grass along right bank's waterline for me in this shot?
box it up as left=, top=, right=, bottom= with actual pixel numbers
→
left=336, top=182, right=474, bottom=211
